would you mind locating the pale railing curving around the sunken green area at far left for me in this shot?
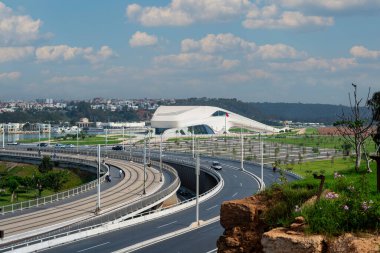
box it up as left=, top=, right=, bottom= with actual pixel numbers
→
left=0, top=151, right=108, bottom=215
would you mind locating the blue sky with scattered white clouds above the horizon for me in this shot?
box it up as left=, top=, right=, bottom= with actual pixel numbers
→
left=0, top=0, right=380, bottom=104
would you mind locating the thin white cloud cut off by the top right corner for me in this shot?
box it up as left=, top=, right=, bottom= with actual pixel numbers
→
left=275, top=0, right=380, bottom=11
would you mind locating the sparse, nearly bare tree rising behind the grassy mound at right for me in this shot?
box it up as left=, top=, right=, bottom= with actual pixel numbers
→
left=334, top=84, right=373, bottom=172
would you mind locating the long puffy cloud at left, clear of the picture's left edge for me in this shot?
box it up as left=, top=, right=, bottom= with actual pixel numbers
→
left=36, top=45, right=115, bottom=64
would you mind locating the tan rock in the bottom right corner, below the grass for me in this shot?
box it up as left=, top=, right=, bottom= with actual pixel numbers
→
left=328, top=233, right=380, bottom=253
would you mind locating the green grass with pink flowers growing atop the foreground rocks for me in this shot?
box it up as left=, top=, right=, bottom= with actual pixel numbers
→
left=262, top=158, right=380, bottom=236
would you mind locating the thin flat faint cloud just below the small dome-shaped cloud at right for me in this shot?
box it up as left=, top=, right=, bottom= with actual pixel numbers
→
left=269, top=58, right=357, bottom=72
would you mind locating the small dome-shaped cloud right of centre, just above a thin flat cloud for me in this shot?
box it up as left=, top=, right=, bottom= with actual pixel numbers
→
left=255, top=44, right=306, bottom=59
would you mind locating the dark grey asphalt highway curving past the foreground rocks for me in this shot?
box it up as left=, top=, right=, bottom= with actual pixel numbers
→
left=44, top=155, right=294, bottom=253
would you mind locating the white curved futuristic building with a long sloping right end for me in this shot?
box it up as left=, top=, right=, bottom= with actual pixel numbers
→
left=151, top=106, right=280, bottom=135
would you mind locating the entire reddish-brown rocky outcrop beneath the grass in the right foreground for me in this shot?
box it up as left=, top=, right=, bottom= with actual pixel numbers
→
left=217, top=195, right=380, bottom=253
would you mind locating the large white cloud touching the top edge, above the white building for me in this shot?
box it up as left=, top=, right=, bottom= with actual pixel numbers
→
left=126, top=0, right=252, bottom=26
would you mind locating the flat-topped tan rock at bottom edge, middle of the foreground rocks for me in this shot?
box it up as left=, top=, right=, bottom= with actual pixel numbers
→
left=261, top=228, right=325, bottom=253
